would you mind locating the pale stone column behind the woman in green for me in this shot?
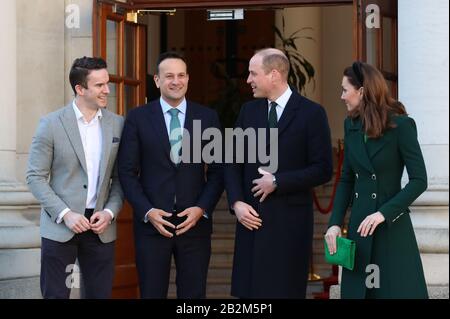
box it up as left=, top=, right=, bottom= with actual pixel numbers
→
left=398, top=0, right=449, bottom=298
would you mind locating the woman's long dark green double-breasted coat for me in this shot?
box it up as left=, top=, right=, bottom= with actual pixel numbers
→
left=329, top=116, right=428, bottom=298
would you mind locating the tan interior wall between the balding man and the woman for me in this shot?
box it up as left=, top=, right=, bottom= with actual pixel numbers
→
left=276, top=6, right=353, bottom=146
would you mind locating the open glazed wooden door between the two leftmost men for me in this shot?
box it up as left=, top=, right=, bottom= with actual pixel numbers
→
left=94, top=1, right=147, bottom=298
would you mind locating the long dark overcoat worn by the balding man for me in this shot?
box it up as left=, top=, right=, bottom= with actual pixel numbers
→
left=225, top=92, right=332, bottom=298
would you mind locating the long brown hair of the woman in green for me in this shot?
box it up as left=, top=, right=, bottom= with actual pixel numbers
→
left=344, top=61, right=407, bottom=138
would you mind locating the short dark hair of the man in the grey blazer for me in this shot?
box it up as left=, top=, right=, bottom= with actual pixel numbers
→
left=69, top=56, right=107, bottom=96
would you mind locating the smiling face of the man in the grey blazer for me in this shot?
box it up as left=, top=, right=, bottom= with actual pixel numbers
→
left=77, top=69, right=109, bottom=109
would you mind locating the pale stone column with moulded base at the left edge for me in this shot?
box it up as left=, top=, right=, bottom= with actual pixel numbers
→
left=0, top=0, right=39, bottom=298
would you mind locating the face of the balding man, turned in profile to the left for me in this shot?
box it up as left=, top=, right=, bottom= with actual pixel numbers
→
left=247, top=55, right=272, bottom=98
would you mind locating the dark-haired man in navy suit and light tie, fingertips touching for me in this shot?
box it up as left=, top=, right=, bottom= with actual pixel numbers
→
left=118, top=53, right=223, bottom=298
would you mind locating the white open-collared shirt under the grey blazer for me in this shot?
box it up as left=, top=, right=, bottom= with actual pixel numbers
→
left=57, top=100, right=114, bottom=223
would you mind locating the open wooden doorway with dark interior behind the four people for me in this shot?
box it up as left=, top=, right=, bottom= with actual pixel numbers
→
left=94, top=0, right=396, bottom=298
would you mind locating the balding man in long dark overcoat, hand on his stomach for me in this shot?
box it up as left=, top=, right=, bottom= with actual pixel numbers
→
left=225, top=49, right=332, bottom=298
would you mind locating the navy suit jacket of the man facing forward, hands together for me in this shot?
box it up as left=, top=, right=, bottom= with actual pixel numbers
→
left=118, top=100, right=223, bottom=235
